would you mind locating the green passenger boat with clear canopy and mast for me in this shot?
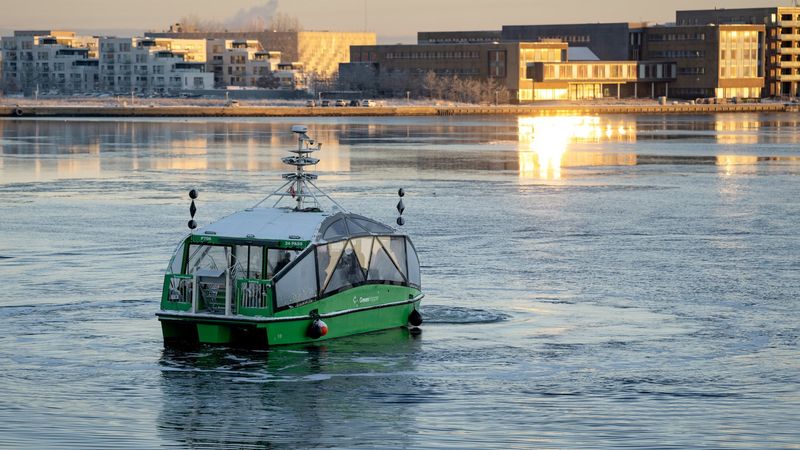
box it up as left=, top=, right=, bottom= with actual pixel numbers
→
left=152, top=126, right=423, bottom=347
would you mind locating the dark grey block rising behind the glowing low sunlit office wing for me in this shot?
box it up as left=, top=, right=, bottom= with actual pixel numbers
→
left=501, top=22, right=647, bottom=61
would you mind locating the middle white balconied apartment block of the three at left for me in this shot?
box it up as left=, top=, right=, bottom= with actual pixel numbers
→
left=99, top=37, right=214, bottom=94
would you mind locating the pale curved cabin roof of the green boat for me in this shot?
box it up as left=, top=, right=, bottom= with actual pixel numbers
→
left=192, top=208, right=398, bottom=246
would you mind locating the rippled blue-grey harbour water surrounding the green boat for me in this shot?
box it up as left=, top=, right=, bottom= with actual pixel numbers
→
left=0, top=114, right=800, bottom=449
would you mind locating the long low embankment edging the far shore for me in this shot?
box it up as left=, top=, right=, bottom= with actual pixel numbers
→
left=0, top=103, right=800, bottom=117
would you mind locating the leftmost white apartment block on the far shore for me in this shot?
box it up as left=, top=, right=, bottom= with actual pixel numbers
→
left=0, top=30, right=100, bottom=95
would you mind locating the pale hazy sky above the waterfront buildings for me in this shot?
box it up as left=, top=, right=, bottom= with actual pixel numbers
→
left=0, top=0, right=792, bottom=41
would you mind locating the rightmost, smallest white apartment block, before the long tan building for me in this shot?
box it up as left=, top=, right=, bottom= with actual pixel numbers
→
left=207, top=39, right=281, bottom=88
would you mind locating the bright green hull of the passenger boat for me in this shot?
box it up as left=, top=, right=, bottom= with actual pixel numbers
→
left=153, top=284, right=422, bottom=348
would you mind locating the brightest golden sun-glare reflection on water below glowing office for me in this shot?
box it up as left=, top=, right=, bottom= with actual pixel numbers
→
left=517, top=116, right=636, bottom=180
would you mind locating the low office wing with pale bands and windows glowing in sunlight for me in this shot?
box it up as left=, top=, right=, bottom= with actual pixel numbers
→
left=528, top=61, right=677, bottom=101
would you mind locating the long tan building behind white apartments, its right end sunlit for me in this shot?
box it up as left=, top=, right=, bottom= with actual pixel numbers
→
left=145, top=31, right=376, bottom=79
